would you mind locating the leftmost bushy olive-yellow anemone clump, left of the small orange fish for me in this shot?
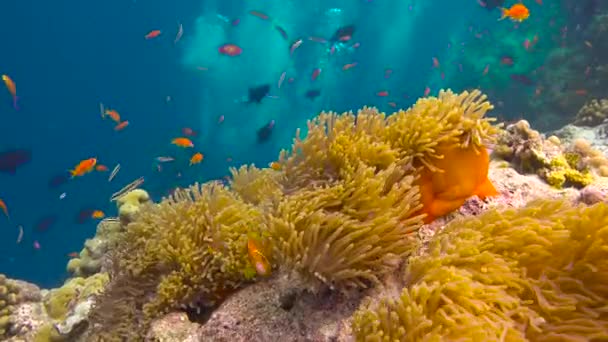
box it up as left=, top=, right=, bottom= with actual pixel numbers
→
left=117, top=183, right=265, bottom=317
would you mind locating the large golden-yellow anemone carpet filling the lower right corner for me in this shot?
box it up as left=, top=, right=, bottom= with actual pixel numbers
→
left=354, top=201, right=608, bottom=341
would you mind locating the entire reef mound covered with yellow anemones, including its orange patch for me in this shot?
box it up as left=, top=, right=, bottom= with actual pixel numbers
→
left=11, top=91, right=608, bottom=342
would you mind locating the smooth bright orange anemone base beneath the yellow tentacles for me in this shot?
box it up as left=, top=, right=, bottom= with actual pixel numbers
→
left=418, top=142, right=498, bottom=223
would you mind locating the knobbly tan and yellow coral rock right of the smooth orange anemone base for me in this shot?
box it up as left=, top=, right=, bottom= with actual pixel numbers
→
left=494, top=120, right=608, bottom=188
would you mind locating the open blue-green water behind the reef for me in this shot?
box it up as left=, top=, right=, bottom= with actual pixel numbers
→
left=0, top=0, right=608, bottom=287
